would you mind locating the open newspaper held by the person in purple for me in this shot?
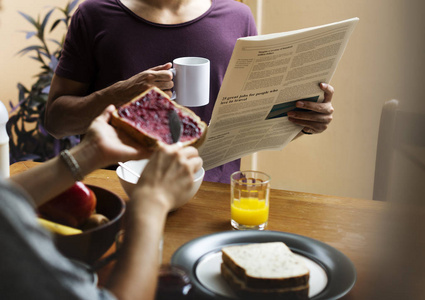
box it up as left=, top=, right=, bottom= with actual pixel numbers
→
left=199, top=18, right=359, bottom=170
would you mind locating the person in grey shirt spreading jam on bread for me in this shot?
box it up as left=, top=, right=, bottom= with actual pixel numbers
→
left=0, top=105, right=202, bottom=300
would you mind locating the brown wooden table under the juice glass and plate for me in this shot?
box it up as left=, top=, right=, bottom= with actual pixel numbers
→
left=10, top=162, right=387, bottom=299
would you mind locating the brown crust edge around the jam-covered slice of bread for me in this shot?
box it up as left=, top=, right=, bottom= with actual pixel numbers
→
left=111, top=87, right=208, bottom=149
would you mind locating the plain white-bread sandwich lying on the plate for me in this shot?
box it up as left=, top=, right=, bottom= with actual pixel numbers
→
left=221, top=242, right=310, bottom=299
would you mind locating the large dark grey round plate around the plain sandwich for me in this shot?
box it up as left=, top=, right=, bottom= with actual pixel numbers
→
left=171, top=230, right=356, bottom=300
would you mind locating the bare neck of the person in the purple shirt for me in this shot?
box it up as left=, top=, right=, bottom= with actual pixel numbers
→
left=121, top=0, right=212, bottom=24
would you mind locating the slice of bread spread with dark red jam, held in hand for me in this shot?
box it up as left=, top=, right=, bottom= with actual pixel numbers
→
left=111, top=87, right=208, bottom=149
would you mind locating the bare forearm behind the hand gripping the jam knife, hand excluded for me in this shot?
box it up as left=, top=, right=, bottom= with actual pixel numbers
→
left=107, top=192, right=168, bottom=300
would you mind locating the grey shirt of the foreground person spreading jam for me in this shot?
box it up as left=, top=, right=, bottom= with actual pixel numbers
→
left=0, top=180, right=116, bottom=300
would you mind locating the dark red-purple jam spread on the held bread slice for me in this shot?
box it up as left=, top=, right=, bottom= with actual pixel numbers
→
left=118, top=90, right=201, bottom=144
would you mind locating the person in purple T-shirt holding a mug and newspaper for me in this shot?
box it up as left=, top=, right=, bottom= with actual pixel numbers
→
left=45, top=0, right=333, bottom=183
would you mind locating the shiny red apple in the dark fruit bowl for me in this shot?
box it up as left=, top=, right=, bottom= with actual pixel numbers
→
left=38, top=181, right=96, bottom=228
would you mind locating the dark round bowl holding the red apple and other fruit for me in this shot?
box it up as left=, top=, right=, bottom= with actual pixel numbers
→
left=54, top=185, right=126, bottom=265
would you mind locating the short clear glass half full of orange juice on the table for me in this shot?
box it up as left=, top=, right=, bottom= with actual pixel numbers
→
left=230, top=171, right=270, bottom=230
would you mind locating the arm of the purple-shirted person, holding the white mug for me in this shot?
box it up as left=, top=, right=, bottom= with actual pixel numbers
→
left=45, top=63, right=173, bottom=138
